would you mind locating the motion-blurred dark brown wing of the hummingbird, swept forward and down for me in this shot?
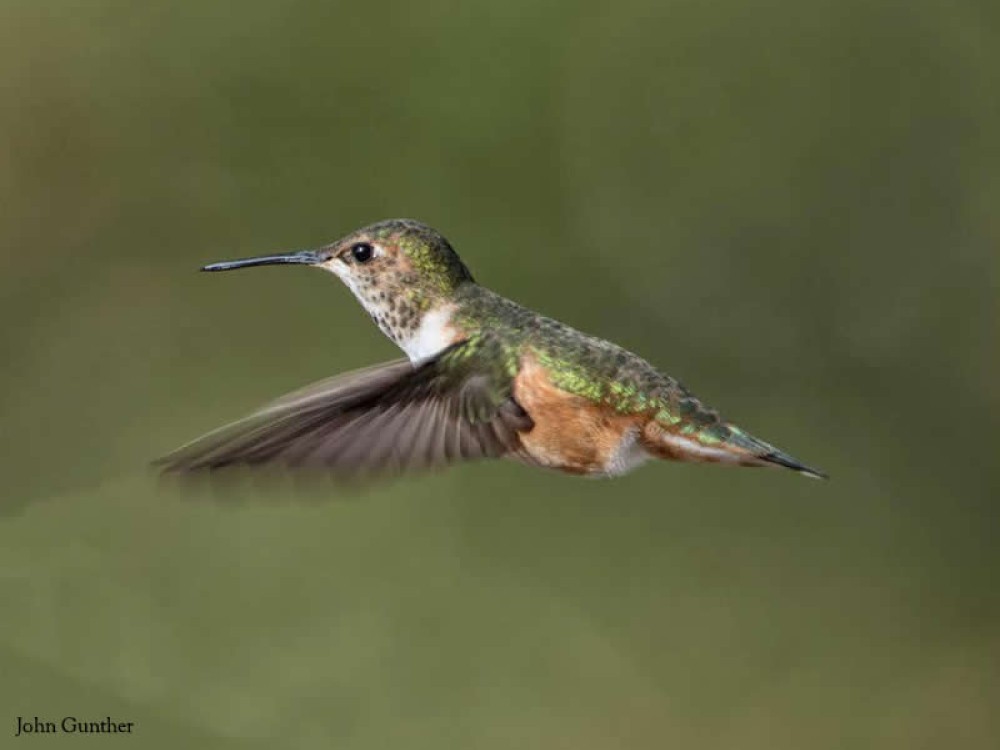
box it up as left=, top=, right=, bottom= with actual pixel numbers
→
left=157, top=337, right=532, bottom=477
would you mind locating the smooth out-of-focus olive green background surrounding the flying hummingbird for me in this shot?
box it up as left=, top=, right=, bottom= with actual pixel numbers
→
left=0, top=0, right=1000, bottom=750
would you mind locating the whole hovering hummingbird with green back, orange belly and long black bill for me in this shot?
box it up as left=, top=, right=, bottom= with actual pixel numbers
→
left=158, top=219, right=826, bottom=480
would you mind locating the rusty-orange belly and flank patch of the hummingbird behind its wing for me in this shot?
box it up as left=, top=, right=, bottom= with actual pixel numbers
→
left=514, top=359, right=649, bottom=476
